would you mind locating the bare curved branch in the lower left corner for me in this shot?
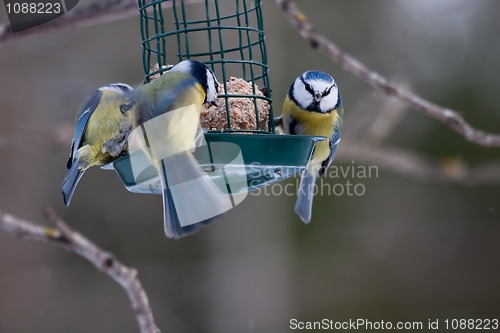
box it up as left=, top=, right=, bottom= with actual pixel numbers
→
left=0, top=208, right=159, bottom=333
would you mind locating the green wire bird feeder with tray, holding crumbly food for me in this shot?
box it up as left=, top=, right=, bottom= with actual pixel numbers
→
left=104, top=0, right=325, bottom=194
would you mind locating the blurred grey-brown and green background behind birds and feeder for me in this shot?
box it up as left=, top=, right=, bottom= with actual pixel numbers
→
left=0, top=0, right=500, bottom=333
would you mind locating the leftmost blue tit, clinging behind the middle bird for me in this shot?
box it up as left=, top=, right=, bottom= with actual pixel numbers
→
left=62, top=83, right=133, bottom=206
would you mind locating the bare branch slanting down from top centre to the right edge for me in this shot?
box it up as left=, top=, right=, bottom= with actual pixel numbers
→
left=275, top=0, right=500, bottom=147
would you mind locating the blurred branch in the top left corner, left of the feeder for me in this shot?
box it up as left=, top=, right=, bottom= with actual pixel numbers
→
left=0, top=0, right=202, bottom=45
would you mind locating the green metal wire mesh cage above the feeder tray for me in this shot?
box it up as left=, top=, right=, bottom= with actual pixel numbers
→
left=138, top=0, right=274, bottom=133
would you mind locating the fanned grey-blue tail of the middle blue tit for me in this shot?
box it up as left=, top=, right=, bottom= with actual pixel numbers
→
left=159, top=152, right=232, bottom=238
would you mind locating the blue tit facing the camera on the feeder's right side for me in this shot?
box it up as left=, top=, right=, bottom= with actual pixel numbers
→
left=275, top=71, right=343, bottom=223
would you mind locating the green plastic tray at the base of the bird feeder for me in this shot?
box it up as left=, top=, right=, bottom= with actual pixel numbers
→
left=103, top=133, right=326, bottom=194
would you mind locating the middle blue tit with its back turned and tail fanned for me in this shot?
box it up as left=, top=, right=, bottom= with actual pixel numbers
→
left=129, top=60, right=231, bottom=238
